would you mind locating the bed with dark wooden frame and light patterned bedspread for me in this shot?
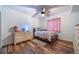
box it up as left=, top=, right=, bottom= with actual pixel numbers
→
left=33, top=29, right=58, bottom=43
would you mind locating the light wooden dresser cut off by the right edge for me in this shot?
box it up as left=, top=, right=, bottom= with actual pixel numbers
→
left=73, top=25, right=79, bottom=54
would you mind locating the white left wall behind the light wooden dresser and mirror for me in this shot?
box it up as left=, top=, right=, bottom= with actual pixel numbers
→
left=1, top=7, right=39, bottom=46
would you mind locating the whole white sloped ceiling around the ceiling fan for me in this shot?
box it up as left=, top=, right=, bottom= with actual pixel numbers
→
left=5, top=5, right=79, bottom=16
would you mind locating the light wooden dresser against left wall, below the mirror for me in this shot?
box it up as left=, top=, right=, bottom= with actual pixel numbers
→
left=14, top=32, right=33, bottom=45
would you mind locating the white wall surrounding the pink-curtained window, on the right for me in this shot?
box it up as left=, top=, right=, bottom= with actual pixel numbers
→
left=41, top=7, right=79, bottom=41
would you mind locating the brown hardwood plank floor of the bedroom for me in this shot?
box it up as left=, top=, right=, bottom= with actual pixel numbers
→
left=1, top=39, right=74, bottom=54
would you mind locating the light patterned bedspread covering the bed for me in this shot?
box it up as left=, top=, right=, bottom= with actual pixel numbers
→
left=35, top=31, right=55, bottom=42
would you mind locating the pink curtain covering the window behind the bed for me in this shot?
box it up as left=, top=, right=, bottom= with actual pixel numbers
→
left=47, top=18, right=60, bottom=32
